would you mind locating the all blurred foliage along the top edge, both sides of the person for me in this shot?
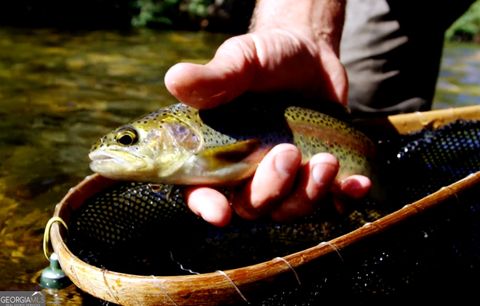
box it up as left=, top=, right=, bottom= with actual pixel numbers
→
left=0, top=0, right=480, bottom=42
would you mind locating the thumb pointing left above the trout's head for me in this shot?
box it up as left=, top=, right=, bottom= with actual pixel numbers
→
left=165, top=35, right=256, bottom=108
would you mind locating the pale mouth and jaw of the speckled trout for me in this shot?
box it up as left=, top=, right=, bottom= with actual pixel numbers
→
left=88, top=151, right=146, bottom=174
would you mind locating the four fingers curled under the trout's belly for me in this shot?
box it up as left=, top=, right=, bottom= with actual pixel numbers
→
left=186, top=144, right=371, bottom=226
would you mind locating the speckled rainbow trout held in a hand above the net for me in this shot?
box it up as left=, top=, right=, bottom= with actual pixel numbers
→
left=89, top=97, right=375, bottom=185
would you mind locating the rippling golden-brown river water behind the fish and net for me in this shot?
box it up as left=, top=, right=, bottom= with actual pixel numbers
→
left=0, top=29, right=480, bottom=303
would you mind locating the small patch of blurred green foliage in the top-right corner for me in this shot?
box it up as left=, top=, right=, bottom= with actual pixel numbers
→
left=445, top=1, right=480, bottom=42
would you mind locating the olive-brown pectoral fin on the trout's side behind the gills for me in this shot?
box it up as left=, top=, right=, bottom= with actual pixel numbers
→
left=198, top=139, right=261, bottom=164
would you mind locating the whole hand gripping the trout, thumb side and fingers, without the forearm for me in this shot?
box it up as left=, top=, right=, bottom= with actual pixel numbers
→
left=165, top=7, right=371, bottom=226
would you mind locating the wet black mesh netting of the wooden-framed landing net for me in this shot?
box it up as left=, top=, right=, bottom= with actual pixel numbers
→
left=67, top=121, right=480, bottom=306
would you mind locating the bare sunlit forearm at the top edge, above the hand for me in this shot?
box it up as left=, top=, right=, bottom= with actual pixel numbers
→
left=250, top=0, right=346, bottom=54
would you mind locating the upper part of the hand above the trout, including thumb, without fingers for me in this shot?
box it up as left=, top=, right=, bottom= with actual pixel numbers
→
left=165, top=29, right=347, bottom=108
